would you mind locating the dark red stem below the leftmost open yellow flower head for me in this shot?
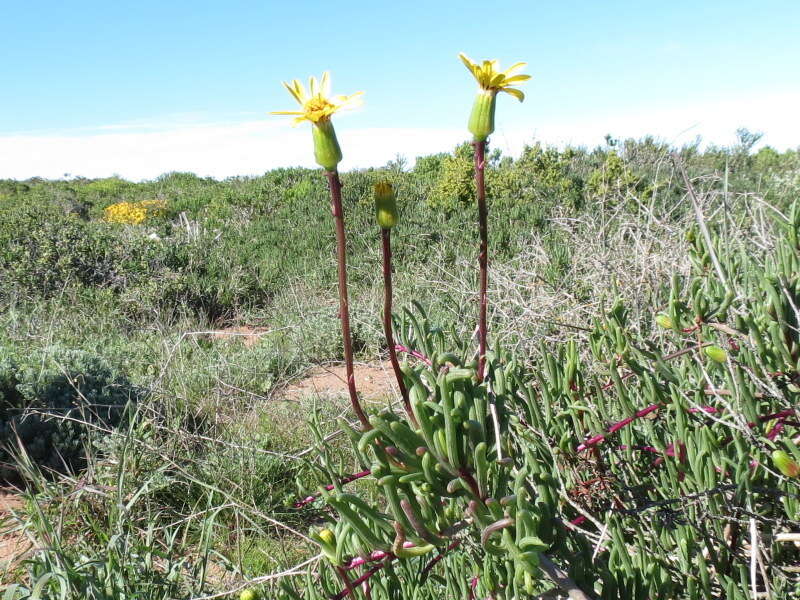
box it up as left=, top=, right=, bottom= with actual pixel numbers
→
left=325, top=171, right=372, bottom=430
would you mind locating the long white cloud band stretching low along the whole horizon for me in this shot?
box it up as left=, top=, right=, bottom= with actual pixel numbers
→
left=0, top=92, right=800, bottom=180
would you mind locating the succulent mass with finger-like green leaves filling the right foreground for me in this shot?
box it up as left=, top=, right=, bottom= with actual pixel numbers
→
left=278, top=205, right=800, bottom=598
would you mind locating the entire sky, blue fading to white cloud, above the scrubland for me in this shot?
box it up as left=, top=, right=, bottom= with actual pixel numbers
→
left=0, top=0, right=800, bottom=179
